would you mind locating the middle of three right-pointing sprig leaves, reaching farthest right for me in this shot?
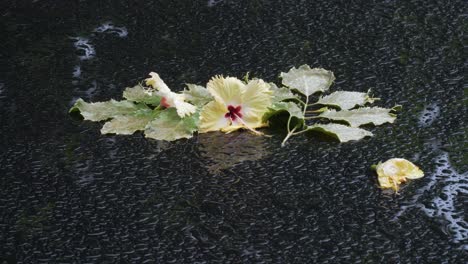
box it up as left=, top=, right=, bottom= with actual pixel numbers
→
left=318, top=107, right=396, bottom=127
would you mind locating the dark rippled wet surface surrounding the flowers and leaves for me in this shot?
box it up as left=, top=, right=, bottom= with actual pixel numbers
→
left=0, top=0, right=468, bottom=263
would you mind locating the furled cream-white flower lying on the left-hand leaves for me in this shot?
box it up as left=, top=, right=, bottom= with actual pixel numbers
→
left=146, top=72, right=196, bottom=117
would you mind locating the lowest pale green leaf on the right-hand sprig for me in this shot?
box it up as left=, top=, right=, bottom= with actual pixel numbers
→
left=307, top=124, right=372, bottom=142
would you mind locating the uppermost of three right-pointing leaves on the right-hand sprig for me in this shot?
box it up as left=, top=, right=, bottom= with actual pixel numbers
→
left=315, top=91, right=378, bottom=110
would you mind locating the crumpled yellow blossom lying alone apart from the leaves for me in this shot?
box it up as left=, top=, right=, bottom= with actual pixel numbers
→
left=376, top=159, right=424, bottom=191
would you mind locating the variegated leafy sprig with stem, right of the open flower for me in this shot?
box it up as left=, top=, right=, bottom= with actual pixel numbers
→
left=264, top=65, right=400, bottom=146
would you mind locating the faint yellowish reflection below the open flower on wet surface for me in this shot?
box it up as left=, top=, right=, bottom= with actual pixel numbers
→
left=198, top=133, right=270, bottom=174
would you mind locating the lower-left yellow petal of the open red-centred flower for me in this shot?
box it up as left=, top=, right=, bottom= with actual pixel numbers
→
left=200, top=101, right=230, bottom=133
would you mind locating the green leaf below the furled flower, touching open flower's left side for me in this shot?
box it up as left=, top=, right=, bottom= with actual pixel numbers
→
left=145, top=108, right=200, bottom=141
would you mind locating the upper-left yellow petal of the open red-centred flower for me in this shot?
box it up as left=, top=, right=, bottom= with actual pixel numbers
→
left=206, top=76, right=245, bottom=106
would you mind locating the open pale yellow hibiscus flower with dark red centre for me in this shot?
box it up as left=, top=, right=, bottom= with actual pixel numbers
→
left=200, top=76, right=271, bottom=133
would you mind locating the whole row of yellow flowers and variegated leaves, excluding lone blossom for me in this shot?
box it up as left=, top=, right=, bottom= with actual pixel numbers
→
left=70, top=65, right=399, bottom=145
